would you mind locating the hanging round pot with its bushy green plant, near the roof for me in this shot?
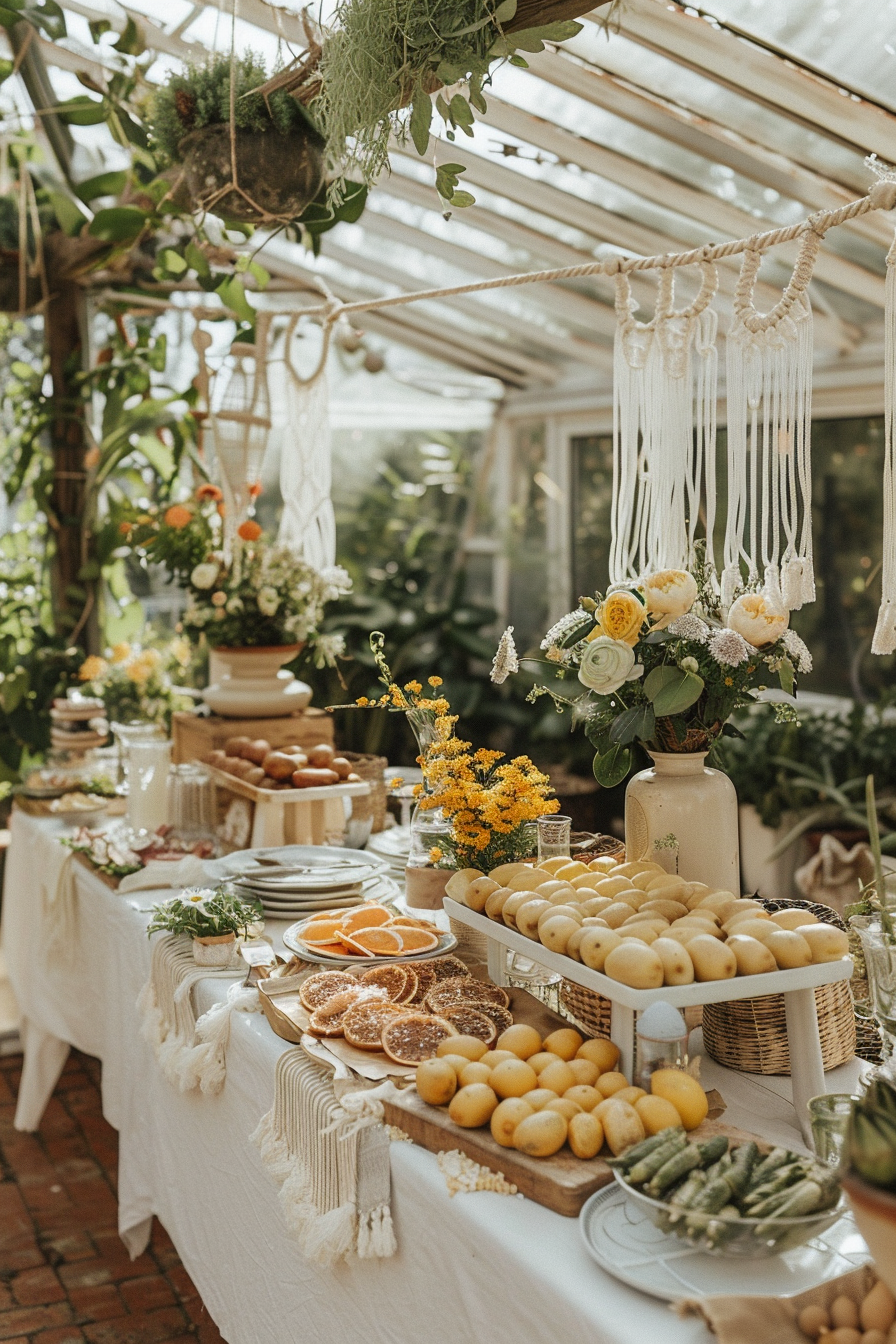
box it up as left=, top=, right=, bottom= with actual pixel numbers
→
left=148, top=51, right=324, bottom=224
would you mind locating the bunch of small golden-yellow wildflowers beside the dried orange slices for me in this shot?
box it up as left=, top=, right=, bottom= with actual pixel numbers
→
left=418, top=715, right=560, bottom=872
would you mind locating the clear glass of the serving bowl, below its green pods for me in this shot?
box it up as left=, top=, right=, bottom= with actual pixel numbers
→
left=613, top=1172, right=846, bottom=1259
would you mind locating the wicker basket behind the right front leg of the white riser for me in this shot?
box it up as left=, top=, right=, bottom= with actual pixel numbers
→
left=703, top=900, right=856, bottom=1074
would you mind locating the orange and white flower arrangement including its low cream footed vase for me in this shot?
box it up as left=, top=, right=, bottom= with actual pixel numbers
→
left=120, top=484, right=351, bottom=718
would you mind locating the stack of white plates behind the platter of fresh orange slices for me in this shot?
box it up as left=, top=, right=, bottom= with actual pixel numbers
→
left=207, top=845, right=399, bottom=921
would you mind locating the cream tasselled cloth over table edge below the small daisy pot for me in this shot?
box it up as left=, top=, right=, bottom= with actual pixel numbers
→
left=137, top=937, right=261, bottom=1097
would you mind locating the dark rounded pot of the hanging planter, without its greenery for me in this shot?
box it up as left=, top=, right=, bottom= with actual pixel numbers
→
left=179, top=124, right=324, bottom=224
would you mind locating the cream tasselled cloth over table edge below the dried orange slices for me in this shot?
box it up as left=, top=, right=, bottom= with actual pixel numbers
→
left=250, top=1048, right=398, bottom=1265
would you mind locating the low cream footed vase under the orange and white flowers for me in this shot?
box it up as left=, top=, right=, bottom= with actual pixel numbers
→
left=203, top=644, right=312, bottom=719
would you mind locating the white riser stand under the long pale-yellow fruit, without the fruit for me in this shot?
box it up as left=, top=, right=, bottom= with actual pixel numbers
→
left=445, top=896, right=853, bottom=1146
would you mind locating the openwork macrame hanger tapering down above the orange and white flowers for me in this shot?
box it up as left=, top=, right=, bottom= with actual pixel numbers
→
left=206, top=313, right=271, bottom=554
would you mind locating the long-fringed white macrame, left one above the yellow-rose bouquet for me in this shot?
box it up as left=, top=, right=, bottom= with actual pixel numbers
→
left=610, top=262, right=719, bottom=585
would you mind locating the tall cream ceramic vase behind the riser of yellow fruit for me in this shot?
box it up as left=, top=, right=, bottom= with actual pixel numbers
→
left=626, top=751, right=740, bottom=895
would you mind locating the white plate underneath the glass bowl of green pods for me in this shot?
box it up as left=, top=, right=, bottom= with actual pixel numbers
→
left=579, top=1185, right=870, bottom=1302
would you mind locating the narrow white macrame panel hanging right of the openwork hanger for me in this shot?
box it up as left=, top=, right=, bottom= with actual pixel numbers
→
left=279, top=316, right=336, bottom=569
